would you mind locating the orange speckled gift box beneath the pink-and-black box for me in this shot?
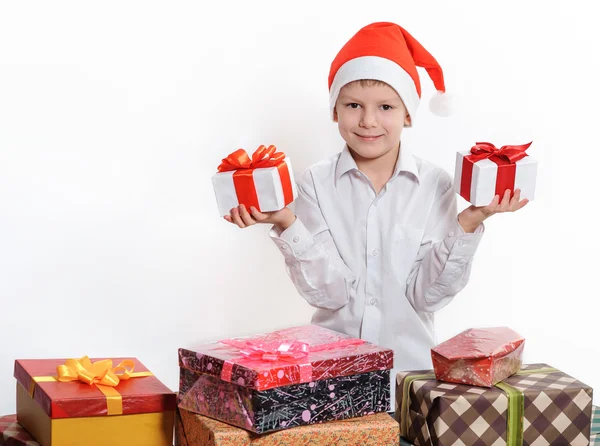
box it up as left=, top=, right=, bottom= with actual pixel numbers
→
left=175, top=409, right=400, bottom=446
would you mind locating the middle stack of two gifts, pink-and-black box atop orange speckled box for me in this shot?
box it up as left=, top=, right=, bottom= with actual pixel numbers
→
left=176, top=325, right=399, bottom=446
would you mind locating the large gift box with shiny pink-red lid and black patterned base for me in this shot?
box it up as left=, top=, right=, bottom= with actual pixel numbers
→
left=179, top=325, right=393, bottom=433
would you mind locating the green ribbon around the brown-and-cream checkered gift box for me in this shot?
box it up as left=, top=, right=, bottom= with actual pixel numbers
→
left=400, top=367, right=559, bottom=446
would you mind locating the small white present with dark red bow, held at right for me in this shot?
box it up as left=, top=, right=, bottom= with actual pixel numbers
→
left=454, top=142, right=537, bottom=206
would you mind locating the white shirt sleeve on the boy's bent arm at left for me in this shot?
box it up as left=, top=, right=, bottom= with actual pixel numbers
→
left=270, top=171, right=358, bottom=310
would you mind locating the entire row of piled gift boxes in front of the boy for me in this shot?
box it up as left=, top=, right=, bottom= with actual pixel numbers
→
left=0, top=325, right=600, bottom=446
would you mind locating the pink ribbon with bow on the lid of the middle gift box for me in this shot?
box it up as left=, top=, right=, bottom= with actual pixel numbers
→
left=219, top=338, right=365, bottom=382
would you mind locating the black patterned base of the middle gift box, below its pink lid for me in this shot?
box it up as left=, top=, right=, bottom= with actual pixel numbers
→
left=179, top=369, right=390, bottom=433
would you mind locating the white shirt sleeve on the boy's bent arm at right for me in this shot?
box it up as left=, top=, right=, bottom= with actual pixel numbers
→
left=406, top=172, right=484, bottom=312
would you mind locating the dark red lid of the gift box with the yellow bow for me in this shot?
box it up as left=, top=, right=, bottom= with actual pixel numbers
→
left=14, top=358, right=176, bottom=419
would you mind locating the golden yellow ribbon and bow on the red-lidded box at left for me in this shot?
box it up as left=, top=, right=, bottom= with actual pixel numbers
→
left=29, top=356, right=153, bottom=415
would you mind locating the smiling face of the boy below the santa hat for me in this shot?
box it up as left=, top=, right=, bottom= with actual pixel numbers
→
left=334, top=82, right=410, bottom=159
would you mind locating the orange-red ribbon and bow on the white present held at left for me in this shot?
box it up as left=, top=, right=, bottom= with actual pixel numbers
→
left=217, top=145, right=294, bottom=211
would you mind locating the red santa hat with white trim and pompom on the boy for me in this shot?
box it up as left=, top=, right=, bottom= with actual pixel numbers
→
left=329, top=22, right=450, bottom=125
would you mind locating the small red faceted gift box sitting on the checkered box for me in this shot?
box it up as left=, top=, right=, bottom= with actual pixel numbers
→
left=431, top=327, right=525, bottom=387
